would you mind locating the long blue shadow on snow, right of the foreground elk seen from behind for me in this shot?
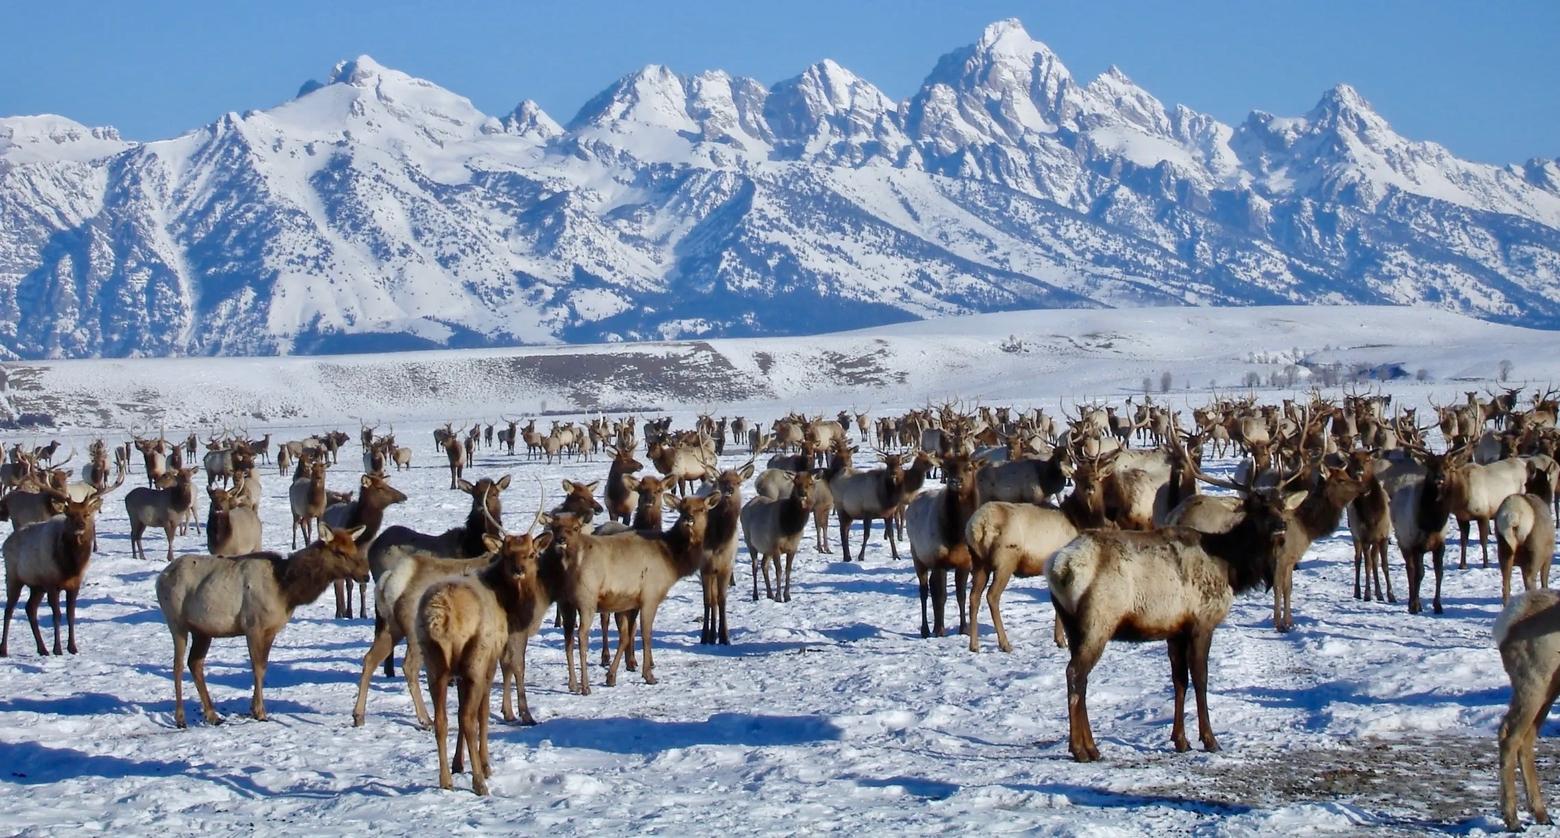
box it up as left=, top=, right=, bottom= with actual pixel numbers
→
left=521, top=713, right=844, bottom=755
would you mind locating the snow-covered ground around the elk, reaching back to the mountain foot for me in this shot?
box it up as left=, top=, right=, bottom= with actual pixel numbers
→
left=0, top=309, right=1560, bottom=835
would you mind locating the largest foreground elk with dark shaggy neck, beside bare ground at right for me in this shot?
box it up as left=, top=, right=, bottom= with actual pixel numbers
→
left=1045, top=478, right=1304, bottom=762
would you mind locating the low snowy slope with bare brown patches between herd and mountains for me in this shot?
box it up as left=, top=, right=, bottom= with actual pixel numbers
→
left=5, top=306, right=1560, bottom=428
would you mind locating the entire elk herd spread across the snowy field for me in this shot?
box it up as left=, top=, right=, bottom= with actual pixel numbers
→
left=0, top=389, right=1560, bottom=827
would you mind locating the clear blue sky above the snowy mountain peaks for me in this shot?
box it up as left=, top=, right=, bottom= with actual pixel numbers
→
left=0, top=0, right=1560, bottom=162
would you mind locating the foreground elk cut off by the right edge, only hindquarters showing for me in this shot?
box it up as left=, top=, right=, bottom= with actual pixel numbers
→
left=1494, top=590, right=1560, bottom=832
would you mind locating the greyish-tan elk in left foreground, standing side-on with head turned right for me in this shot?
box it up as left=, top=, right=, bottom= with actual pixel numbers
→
left=158, top=524, right=368, bottom=727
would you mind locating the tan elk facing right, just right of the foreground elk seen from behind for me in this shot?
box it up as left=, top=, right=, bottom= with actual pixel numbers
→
left=551, top=498, right=710, bottom=694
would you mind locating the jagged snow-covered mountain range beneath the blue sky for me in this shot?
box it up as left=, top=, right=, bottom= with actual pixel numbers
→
left=0, top=20, right=1560, bottom=357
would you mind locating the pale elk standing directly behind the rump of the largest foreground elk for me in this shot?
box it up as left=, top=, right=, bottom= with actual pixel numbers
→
left=964, top=457, right=1114, bottom=652
